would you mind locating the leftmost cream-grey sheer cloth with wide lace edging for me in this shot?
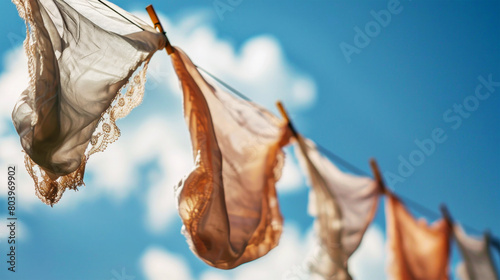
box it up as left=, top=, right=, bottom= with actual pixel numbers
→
left=12, top=0, right=165, bottom=205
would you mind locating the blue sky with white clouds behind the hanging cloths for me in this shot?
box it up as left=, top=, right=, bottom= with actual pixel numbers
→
left=0, top=0, right=500, bottom=280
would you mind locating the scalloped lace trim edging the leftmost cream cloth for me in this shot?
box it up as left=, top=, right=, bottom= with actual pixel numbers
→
left=12, top=0, right=151, bottom=206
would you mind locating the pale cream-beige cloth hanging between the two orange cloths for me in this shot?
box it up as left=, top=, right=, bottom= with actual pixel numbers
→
left=295, top=136, right=380, bottom=280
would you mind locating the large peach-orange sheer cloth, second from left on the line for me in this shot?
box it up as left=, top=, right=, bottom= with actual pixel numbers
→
left=171, top=48, right=289, bottom=269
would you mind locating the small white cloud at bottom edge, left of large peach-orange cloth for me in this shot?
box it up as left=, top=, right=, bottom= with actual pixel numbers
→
left=140, top=247, right=192, bottom=280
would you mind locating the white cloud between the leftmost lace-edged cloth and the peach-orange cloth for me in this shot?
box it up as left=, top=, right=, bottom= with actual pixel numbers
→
left=59, top=115, right=192, bottom=229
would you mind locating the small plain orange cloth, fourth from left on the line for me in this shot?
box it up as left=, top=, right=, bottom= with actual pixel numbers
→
left=386, top=194, right=451, bottom=280
